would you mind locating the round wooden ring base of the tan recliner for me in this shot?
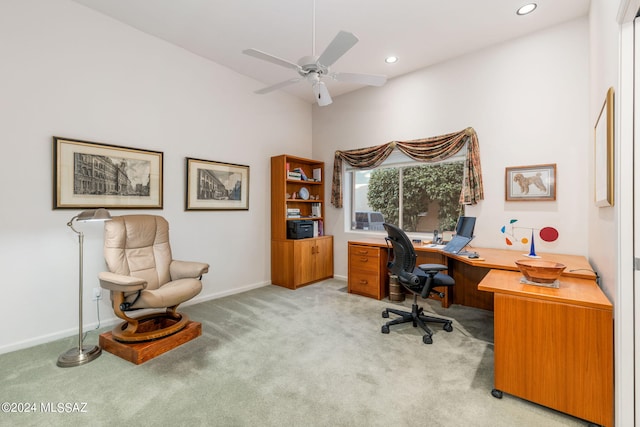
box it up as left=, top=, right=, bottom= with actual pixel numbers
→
left=111, top=312, right=189, bottom=342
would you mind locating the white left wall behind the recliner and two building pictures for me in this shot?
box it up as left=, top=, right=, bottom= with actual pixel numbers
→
left=0, top=0, right=311, bottom=353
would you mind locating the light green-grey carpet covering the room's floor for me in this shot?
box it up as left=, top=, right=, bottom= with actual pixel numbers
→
left=0, top=280, right=585, bottom=427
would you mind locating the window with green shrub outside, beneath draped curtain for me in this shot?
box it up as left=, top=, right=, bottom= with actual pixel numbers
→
left=347, top=150, right=466, bottom=232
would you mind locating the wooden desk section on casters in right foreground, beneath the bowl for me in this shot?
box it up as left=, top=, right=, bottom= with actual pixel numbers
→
left=478, top=269, right=614, bottom=426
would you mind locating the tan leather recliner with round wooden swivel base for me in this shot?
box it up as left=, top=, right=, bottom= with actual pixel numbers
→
left=98, top=215, right=209, bottom=342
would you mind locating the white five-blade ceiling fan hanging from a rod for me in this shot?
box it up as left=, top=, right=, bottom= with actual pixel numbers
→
left=242, top=0, right=387, bottom=107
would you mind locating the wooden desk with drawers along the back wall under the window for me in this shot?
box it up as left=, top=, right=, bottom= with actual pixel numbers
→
left=348, top=238, right=596, bottom=310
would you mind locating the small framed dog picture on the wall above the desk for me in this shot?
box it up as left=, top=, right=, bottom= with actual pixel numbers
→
left=504, top=163, right=556, bottom=201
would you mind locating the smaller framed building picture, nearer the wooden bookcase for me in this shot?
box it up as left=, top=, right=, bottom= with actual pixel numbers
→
left=185, top=157, right=249, bottom=211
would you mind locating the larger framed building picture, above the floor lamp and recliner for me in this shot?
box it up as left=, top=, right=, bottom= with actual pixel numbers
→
left=53, top=136, right=163, bottom=209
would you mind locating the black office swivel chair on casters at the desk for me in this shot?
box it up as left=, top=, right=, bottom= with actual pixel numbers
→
left=382, top=223, right=455, bottom=344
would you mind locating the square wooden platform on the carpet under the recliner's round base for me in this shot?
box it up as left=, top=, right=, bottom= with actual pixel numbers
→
left=99, top=321, right=202, bottom=365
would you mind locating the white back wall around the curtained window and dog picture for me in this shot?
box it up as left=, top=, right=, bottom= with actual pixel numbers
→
left=313, top=17, right=593, bottom=276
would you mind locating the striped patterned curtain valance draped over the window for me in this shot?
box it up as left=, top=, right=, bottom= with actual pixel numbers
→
left=331, top=127, right=484, bottom=208
